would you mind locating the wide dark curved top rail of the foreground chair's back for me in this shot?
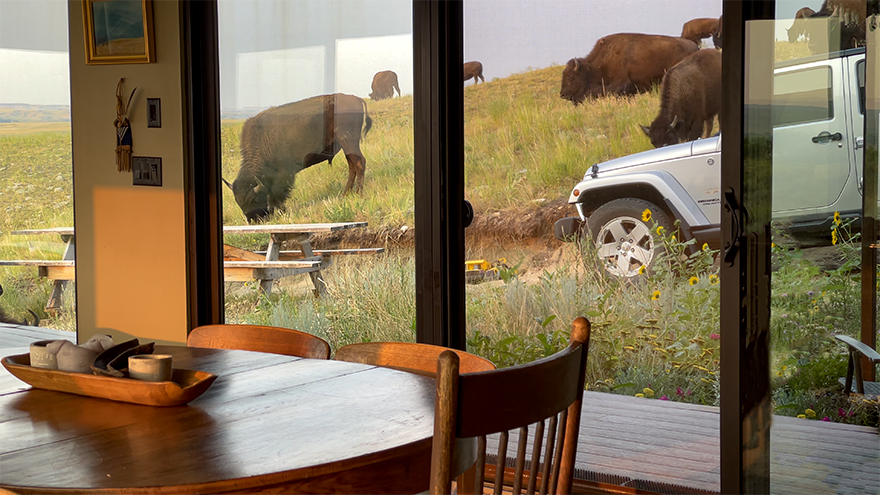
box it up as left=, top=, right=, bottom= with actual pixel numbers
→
left=456, top=345, right=584, bottom=438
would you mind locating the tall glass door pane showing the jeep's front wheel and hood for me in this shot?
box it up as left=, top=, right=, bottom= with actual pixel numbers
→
left=463, top=0, right=721, bottom=492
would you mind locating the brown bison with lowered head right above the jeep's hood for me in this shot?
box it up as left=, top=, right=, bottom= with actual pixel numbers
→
left=642, top=48, right=721, bottom=148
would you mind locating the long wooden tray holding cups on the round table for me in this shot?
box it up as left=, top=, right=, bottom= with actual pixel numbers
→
left=0, top=354, right=217, bottom=406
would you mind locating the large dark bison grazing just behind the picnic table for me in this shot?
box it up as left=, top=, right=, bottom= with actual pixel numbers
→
left=223, top=93, right=373, bottom=222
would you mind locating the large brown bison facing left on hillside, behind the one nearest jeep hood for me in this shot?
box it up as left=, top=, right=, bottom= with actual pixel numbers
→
left=559, top=33, right=699, bottom=106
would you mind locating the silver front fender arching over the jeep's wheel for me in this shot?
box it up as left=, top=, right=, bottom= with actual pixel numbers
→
left=568, top=170, right=710, bottom=230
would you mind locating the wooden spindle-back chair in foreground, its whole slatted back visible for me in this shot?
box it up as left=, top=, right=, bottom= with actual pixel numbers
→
left=431, top=317, right=590, bottom=495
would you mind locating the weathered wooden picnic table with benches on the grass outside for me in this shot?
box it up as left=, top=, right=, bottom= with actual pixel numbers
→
left=0, top=222, right=385, bottom=312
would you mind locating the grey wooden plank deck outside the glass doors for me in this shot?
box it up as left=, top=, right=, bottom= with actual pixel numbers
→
left=0, top=324, right=880, bottom=495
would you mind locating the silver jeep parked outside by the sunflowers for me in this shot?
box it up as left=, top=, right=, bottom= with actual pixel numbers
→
left=554, top=48, right=865, bottom=277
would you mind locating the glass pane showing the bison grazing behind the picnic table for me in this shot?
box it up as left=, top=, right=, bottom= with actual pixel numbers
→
left=219, top=0, right=415, bottom=351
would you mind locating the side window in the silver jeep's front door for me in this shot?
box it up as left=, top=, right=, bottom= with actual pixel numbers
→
left=771, top=66, right=834, bottom=127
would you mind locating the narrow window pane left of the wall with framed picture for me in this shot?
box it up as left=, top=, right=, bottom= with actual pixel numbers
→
left=0, top=0, right=76, bottom=340
